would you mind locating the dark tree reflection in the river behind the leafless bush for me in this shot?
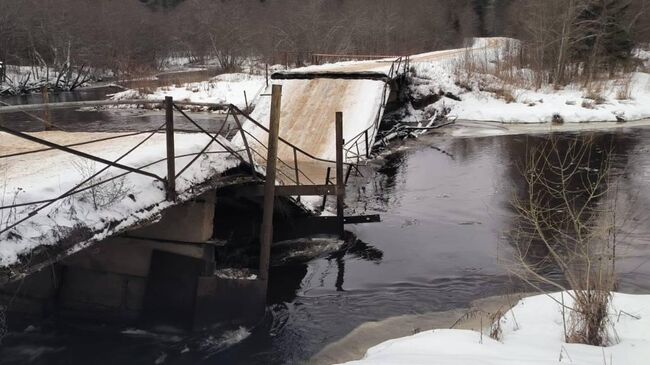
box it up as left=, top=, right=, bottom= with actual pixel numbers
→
left=496, top=132, right=647, bottom=290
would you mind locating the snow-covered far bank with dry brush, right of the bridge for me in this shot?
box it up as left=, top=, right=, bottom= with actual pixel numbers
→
left=411, top=40, right=650, bottom=123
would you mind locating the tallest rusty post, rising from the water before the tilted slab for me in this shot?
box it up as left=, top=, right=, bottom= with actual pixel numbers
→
left=260, top=85, right=282, bottom=281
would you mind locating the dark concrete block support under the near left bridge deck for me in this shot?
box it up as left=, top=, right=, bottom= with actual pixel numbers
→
left=0, top=191, right=266, bottom=330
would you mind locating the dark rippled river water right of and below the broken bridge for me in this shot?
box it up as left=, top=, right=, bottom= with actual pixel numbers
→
left=0, top=90, right=650, bottom=364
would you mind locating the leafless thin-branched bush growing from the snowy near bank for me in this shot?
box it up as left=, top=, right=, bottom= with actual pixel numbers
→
left=510, top=135, right=618, bottom=346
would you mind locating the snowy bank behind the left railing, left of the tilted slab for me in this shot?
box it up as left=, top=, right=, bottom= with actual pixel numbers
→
left=112, top=73, right=266, bottom=109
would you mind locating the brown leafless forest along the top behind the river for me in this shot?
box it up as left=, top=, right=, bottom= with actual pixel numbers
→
left=0, top=0, right=650, bottom=78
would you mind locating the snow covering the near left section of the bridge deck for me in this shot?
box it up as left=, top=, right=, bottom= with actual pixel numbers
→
left=0, top=132, right=239, bottom=267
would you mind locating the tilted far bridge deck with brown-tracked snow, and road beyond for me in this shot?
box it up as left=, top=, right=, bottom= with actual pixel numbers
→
left=237, top=38, right=505, bottom=183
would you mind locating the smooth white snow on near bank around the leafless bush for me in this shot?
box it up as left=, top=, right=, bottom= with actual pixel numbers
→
left=340, top=293, right=650, bottom=365
